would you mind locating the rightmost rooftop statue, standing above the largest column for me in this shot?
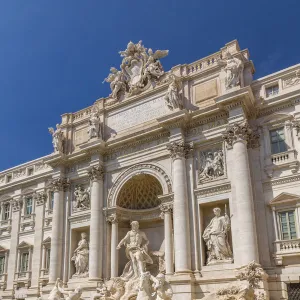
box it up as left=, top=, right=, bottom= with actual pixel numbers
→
left=218, top=52, right=243, bottom=89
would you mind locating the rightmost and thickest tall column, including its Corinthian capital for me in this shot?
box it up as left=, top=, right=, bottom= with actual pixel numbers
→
left=223, top=123, right=258, bottom=265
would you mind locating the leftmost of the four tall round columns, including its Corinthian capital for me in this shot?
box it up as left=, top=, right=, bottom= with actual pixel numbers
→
left=49, top=178, right=70, bottom=283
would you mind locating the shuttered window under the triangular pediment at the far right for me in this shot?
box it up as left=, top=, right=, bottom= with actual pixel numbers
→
left=278, top=210, right=297, bottom=240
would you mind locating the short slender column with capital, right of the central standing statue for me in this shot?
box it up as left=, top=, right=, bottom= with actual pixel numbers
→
left=160, top=203, right=174, bottom=275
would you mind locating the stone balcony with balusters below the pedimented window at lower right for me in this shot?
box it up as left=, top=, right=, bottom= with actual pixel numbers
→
left=273, top=239, right=300, bottom=265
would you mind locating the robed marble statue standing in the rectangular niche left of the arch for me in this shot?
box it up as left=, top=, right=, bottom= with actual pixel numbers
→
left=71, top=232, right=89, bottom=277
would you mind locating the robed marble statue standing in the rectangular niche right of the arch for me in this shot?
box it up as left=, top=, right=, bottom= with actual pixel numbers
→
left=203, top=206, right=233, bottom=265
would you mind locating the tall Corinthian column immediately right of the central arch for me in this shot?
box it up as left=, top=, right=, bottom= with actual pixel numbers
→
left=168, top=141, right=191, bottom=273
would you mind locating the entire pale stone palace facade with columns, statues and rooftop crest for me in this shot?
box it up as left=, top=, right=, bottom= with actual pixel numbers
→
left=0, top=41, right=300, bottom=300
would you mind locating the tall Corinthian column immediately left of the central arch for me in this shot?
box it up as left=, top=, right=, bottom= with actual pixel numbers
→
left=88, top=166, right=104, bottom=281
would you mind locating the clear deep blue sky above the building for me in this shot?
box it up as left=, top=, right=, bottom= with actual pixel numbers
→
left=0, top=0, right=300, bottom=170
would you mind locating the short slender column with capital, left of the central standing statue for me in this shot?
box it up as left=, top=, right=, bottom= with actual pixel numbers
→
left=107, top=214, right=119, bottom=278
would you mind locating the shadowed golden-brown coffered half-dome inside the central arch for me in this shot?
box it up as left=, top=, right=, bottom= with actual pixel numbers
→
left=117, top=174, right=163, bottom=210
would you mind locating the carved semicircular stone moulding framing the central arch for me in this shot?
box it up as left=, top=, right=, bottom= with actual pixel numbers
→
left=107, top=164, right=172, bottom=206
